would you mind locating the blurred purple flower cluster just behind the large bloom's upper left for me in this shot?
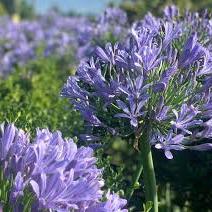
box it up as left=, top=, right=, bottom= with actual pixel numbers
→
left=77, top=8, right=128, bottom=61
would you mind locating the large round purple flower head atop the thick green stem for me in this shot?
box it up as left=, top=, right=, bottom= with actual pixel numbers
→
left=61, top=6, right=212, bottom=159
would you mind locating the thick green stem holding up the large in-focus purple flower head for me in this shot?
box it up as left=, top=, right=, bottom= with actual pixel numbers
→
left=139, top=127, right=158, bottom=212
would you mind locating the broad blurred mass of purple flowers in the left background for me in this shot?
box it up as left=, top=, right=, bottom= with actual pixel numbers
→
left=0, top=16, right=79, bottom=75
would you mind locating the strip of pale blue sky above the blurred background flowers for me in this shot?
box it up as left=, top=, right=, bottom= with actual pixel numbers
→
left=28, top=0, right=121, bottom=13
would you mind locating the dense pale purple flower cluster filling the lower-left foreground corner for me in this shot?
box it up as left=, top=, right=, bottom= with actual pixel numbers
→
left=0, top=124, right=127, bottom=212
